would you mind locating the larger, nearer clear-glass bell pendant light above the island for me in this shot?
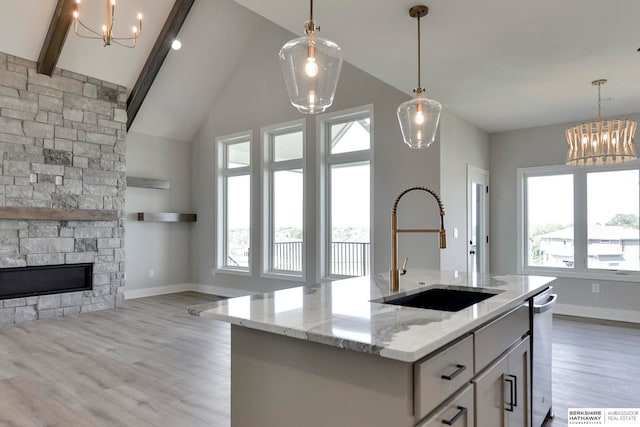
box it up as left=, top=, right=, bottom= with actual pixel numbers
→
left=279, top=0, right=342, bottom=114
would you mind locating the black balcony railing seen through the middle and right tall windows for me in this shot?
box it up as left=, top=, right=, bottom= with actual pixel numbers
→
left=273, top=242, right=371, bottom=276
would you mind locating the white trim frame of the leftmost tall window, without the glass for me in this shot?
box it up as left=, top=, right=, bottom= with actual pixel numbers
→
left=214, top=131, right=254, bottom=276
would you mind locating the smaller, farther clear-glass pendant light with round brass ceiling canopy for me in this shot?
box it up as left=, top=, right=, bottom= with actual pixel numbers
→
left=398, top=5, right=442, bottom=148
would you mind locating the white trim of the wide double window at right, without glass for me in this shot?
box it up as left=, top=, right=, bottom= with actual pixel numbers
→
left=516, top=162, right=640, bottom=282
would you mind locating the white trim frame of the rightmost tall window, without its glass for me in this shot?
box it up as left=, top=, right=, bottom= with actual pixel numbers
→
left=316, top=104, right=375, bottom=281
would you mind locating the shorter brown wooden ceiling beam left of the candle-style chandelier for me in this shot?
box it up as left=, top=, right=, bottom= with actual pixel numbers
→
left=38, top=0, right=74, bottom=76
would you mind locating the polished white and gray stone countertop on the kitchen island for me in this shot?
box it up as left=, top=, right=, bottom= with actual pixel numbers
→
left=189, top=270, right=554, bottom=362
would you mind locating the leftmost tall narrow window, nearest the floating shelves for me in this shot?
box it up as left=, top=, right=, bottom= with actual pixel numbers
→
left=217, top=133, right=251, bottom=271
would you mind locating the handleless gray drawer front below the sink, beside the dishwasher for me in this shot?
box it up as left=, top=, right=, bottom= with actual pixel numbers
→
left=473, top=306, right=529, bottom=373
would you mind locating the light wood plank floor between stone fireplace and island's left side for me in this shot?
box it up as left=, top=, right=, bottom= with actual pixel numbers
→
left=0, top=292, right=230, bottom=427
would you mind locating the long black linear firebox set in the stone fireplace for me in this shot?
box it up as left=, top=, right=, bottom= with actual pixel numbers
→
left=0, top=264, right=93, bottom=299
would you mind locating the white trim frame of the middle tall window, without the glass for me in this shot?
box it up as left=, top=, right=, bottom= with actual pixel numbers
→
left=260, top=119, right=309, bottom=282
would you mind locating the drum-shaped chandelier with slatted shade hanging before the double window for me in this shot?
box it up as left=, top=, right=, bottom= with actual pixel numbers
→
left=567, top=79, right=638, bottom=166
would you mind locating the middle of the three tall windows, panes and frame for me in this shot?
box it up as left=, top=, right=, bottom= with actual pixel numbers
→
left=263, top=121, right=305, bottom=278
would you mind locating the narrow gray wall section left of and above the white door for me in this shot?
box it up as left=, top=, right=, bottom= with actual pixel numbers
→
left=440, top=110, right=490, bottom=271
